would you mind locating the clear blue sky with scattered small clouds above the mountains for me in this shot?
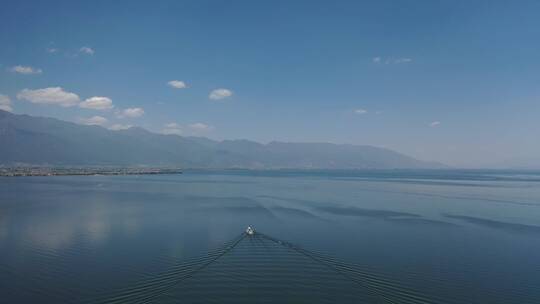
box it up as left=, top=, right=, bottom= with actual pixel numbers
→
left=0, top=0, right=540, bottom=167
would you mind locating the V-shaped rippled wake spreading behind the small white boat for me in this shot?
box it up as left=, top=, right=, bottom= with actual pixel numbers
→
left=91, top=227, right=447, bottom=304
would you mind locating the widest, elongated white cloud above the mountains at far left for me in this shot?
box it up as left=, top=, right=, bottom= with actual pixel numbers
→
left=17, top=87, right=80, bottom=107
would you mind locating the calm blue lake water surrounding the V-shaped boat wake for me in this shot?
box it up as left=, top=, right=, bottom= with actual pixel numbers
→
left=0, top=171, right=540, bottom=303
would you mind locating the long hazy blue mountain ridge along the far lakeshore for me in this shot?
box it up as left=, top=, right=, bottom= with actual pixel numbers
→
left=0, top=110, right=444, bottom=169
